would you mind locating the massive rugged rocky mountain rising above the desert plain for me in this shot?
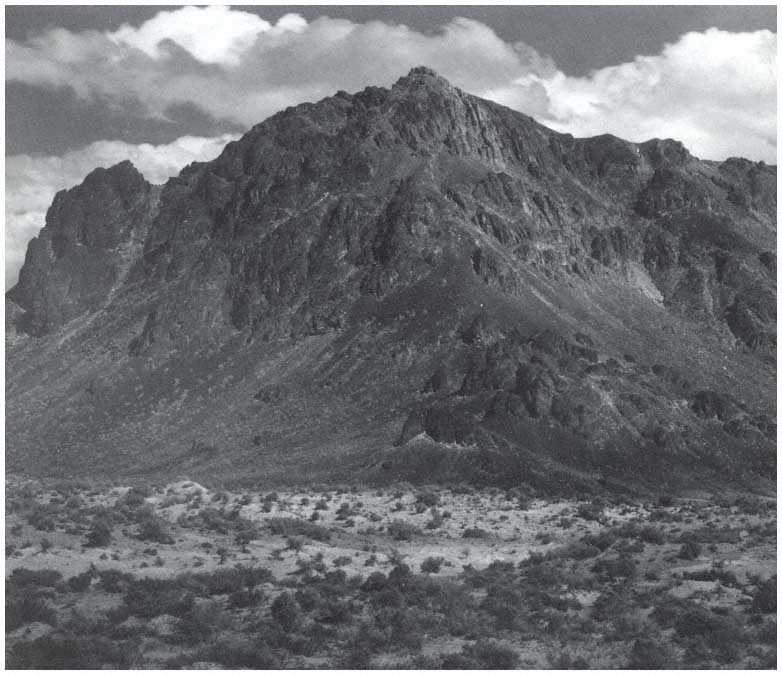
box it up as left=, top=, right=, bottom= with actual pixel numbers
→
left=6, top=68, right=776, bottom=492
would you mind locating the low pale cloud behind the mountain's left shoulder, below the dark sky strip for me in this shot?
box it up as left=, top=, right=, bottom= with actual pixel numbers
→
left=5, top=134, right=237, bottom=288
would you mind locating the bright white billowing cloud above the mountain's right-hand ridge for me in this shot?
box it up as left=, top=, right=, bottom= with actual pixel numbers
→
left=494, top=28, right=776, bottom=163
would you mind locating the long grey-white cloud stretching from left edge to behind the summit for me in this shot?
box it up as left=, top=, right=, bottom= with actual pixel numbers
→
left=6, top=7, right=555, bottom=127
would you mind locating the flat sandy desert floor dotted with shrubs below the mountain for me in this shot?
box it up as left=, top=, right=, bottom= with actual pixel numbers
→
left=6, top=480, right=776, bottom=670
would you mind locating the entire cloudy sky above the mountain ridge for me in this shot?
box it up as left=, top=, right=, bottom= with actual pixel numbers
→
left=5, top=5, right=776, bottom=288
